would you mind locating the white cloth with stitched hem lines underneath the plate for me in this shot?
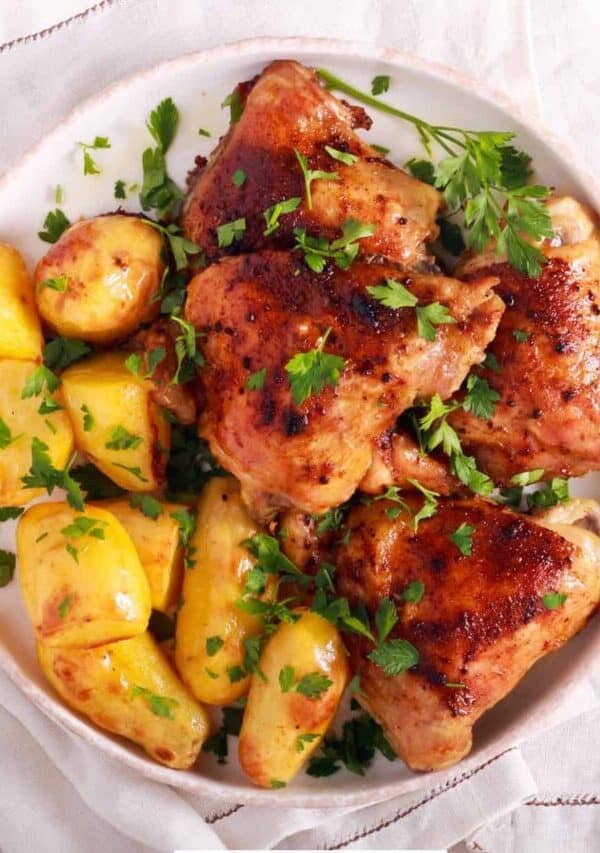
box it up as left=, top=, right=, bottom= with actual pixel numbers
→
left=0, top=0, right=600, bottom=853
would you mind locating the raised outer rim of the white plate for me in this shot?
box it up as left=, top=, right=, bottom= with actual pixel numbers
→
left=0, top=36, right=600, bottom=808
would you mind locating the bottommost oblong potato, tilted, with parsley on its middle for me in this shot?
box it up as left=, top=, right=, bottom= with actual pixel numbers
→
left=239, top=609, right=348, bottom=788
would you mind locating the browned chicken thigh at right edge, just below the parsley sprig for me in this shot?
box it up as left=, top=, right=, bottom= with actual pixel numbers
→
left=451, top=198, right=600, bottom=484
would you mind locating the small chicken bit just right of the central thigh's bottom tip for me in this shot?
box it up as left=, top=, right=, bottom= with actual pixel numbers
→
left=359, top=428, right=460, bottom=495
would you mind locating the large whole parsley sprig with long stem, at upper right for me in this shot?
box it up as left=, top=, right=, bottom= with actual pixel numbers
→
left=318, top=69, right=552, bottom=278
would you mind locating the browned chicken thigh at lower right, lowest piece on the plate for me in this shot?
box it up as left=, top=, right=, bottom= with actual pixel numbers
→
left=332, top=498, right=600, bottom=770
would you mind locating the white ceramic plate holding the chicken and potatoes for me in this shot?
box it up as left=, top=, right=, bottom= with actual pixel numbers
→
left=0, top=39, right=600, bottom=807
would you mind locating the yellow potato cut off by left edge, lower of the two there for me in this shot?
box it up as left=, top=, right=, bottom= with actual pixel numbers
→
left=0, top=358, right=73, bottom=506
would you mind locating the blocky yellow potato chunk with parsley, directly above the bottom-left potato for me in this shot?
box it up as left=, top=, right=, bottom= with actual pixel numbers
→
left=17, top=502, right=150, bottom=648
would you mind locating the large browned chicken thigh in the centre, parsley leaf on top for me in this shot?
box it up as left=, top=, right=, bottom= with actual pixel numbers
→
left=186, top=252, right=503, bottom=519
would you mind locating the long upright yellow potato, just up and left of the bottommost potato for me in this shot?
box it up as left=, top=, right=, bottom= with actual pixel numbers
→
left=175, top=477, right=262, bottom=705
